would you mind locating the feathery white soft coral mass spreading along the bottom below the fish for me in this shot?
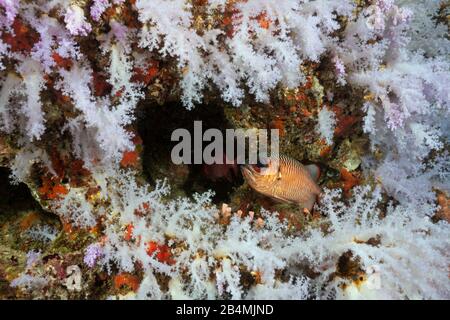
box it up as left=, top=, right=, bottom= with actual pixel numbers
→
left=48, top=172, right=450, bottom=299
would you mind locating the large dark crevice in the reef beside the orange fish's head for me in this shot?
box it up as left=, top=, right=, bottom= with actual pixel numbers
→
left=138, top=103, right=244, bottom=203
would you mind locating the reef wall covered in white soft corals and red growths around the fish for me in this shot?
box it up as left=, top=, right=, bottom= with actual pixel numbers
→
left=0, top=0, right=450, bottom=299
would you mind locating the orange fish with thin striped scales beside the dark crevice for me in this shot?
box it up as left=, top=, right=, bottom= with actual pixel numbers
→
left=241, top=155, right=321, bottom=211
